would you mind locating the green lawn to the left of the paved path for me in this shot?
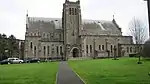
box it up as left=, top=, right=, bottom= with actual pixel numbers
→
left=0, top=62, right=58, bottom=84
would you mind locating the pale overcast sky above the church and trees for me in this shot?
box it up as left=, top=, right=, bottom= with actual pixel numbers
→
left=0, top=0, right=148, bottom=39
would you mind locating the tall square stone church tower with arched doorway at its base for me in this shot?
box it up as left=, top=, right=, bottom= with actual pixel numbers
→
left=62, top=0, right=81, bottom=57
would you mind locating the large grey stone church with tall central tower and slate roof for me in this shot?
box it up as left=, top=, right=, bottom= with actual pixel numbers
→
left=24, top=0, right=142, bottom=59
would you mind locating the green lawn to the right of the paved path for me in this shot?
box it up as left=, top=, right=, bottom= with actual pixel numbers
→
left=69, top=58, right=150, bottom=84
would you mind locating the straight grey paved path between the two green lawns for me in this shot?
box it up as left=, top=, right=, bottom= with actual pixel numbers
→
left=57, top=62, right=84, bottom=84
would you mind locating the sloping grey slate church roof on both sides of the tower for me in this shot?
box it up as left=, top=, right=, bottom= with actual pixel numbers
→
left=28, top=17, right=121, bottom=35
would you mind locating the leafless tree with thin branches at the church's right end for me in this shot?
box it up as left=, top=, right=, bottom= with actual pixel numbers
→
left=129, top=18, right=146, bottom=44
